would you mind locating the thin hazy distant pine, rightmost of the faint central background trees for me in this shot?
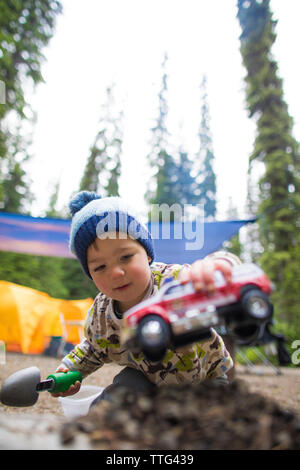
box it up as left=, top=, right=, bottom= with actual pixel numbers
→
left=196, top=76, right=216, bottom=219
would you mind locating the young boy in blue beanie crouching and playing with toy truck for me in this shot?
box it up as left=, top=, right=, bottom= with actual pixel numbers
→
left=53, top=191, right=240, bottom=400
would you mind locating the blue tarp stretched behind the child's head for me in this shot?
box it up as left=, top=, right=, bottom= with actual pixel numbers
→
left=0, top=212, right=255, bottom=264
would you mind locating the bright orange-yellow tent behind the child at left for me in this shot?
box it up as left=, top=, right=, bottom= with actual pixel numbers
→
left=0, top=281, right=93, bottom=354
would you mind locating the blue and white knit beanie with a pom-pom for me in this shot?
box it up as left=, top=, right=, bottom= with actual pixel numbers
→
left=69, top=191, right=154, bottom=278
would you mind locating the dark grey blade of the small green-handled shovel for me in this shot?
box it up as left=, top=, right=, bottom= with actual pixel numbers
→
left=0, top=366, right=41, bottom=407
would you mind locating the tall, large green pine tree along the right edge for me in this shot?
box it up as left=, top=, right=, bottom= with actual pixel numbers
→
left=238, top=0, right=300, bottom=334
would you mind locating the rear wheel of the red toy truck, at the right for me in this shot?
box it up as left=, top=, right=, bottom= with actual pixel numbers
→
left=241, top=289, right=272, bottom=321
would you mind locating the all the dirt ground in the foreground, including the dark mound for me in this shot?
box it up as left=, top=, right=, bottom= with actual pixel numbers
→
left=0, top=354, right=300, bottom=451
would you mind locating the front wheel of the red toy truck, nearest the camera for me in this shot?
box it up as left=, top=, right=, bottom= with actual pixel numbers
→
left=137, top=315, right=170, bottom=361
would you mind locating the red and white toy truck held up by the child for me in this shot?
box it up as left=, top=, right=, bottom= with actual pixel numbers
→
left=122, top=263, right=273, bottom=361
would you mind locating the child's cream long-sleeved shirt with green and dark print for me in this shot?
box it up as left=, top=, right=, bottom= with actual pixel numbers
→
left=62, top=252, right=240, bottom=386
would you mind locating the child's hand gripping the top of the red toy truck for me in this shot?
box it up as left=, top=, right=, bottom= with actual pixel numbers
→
left=178, top=259, right=232, bottom=292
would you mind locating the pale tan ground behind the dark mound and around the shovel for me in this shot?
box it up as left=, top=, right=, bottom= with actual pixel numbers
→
left=0, top=353, right=300, bottom=417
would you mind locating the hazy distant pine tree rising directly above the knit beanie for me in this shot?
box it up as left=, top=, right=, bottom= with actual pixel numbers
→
left=80, top=87, right=123, bottom=196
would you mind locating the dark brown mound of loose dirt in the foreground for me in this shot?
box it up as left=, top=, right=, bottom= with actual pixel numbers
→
left=61, top=380, right=300, bottom=450
